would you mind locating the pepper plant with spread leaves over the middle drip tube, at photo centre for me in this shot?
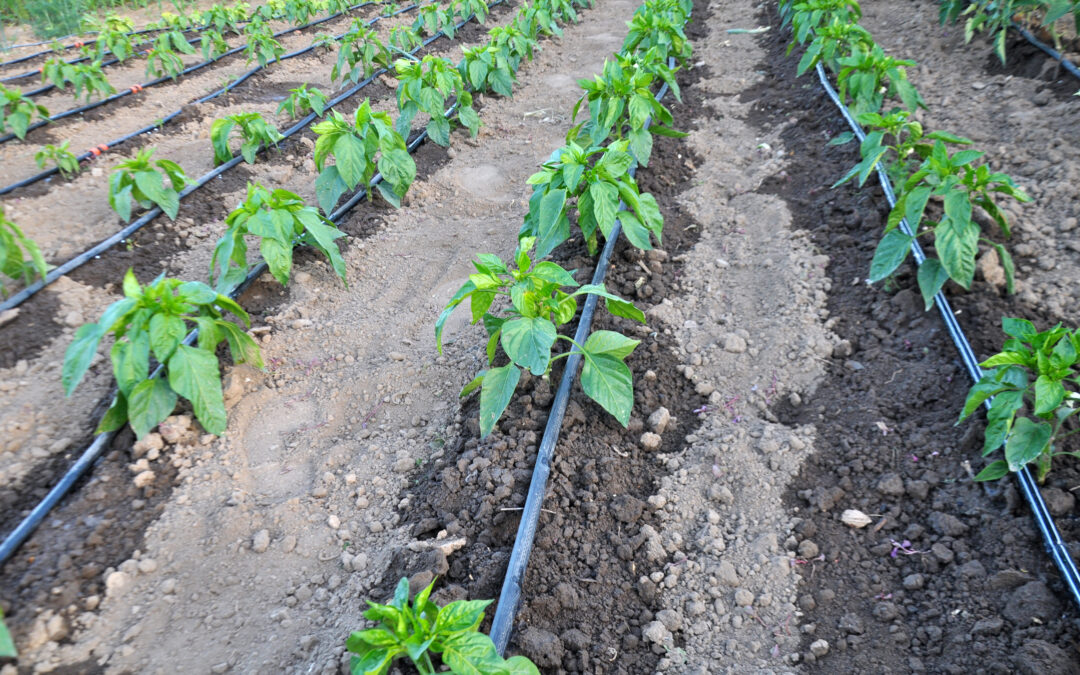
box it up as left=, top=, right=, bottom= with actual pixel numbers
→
left=435, top=237, right=645, bottom=436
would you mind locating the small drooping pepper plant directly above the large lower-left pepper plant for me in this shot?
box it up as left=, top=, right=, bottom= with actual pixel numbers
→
left=109, top=148, right=188, bottom=222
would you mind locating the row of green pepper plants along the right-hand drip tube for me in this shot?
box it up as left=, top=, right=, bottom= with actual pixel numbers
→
left=780, top=0, right=1080, bottom=483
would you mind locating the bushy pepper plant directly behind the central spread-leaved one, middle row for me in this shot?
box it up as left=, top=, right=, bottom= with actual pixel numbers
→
left=521, top=140, right=663, bottom=258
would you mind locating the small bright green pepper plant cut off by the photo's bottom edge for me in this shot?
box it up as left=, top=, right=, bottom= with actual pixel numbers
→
left=346, top=578, right=540, bottom=675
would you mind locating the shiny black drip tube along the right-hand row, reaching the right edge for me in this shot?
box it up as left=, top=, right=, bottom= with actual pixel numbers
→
left=816, top=63, right=1080, bottom=607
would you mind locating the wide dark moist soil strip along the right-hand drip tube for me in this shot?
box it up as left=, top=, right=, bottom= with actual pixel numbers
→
left=744, top=6, right=1080, bottom=673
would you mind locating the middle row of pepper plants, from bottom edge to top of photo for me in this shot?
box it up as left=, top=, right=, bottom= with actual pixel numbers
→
left=347, top=0, right=690, bottom=675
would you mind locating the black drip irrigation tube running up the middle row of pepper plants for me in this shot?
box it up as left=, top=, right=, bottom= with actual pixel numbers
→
left=489, top=58, right=675, bottom=656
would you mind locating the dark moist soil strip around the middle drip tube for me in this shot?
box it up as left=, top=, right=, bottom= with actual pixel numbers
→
left=384, top=55, right=705, bottom=674
